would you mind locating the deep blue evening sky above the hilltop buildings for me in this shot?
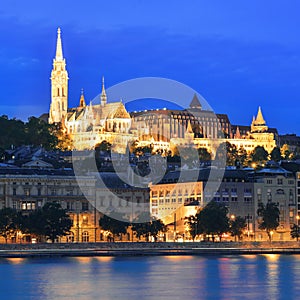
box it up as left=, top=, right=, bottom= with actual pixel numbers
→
left=0, top=0, right=300, bottom=134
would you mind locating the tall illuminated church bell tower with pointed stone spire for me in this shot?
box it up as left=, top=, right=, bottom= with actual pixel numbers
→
left=49, top=28, right=69, bottom=124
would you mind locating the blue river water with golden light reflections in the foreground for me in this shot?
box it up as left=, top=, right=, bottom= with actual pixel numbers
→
left=0, top=254, right=300, bottom=300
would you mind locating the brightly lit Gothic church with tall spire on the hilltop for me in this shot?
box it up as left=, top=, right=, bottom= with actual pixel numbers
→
left=49, top=29, right=132, bottom=152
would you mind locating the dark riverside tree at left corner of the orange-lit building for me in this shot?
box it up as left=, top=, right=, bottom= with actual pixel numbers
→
left=132, top=213, right=167, bottom=242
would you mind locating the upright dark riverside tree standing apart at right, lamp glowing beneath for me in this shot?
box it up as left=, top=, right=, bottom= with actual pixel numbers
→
left=257, top=202, right=280, bottom=241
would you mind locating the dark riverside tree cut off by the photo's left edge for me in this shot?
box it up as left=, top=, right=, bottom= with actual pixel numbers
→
left=0, top=207, right=18, bottom=243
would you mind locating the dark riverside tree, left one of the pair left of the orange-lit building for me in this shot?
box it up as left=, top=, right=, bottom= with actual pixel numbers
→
left=99, top=213, right=129, bottom=240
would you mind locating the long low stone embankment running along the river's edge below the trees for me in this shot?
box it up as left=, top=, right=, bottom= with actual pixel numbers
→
left=0, top=242, right=300, bottom=258
